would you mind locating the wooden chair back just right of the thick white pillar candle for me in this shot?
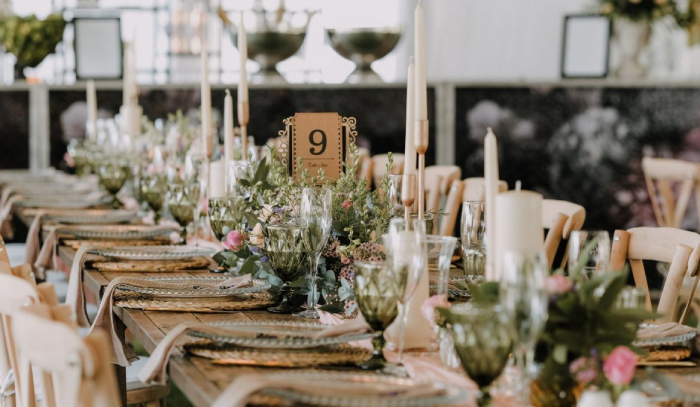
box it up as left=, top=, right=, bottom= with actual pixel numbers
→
left=542, top=199, right=586, bottom=267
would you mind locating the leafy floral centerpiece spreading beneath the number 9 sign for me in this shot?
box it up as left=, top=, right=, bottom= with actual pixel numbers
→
left=214, top=143, right=393, bottom=315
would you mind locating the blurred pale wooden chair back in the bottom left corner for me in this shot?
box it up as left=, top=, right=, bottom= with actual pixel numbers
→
left=13, top=304, right=121, bottom=407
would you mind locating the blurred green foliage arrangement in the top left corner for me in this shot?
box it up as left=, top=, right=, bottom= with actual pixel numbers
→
left=0, top=13, right=66, bottom=79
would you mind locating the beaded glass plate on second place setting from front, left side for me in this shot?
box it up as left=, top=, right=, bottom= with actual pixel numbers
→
left=189, top=321, right=373, bottom=349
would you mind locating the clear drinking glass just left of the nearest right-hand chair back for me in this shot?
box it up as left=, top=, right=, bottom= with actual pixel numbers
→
left=569, top=230, right=610, bottom=279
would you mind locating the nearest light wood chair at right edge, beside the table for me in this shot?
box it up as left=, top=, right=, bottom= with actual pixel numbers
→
left=610, top=227, right=700, bottom=323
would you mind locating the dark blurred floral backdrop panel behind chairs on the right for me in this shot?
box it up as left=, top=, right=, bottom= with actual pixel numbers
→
left=455, top=87, right=700, bottom=230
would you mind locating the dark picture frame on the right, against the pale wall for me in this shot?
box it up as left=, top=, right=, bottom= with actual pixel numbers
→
left=560, top=14, right=612, bottom=79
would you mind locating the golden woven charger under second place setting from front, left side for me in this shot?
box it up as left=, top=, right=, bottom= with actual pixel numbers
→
left=185, top=339, right=372, bottom=367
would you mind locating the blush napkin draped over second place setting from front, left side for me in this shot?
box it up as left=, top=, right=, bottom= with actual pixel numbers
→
left=139, top=310, right=369, bottom=384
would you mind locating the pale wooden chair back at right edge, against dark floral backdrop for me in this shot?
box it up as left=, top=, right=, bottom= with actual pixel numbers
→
left=642, top=157, right=700, bottom=228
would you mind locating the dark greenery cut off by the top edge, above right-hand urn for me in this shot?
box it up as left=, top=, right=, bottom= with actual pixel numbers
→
left=600, top=0, right=688, bottom=23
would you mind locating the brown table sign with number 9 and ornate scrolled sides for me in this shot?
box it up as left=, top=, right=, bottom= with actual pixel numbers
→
left=278, top=113, right=357, bottom=183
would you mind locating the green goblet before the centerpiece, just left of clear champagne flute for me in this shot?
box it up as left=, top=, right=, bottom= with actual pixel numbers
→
left=265, top=225, right=308, bottom=314
